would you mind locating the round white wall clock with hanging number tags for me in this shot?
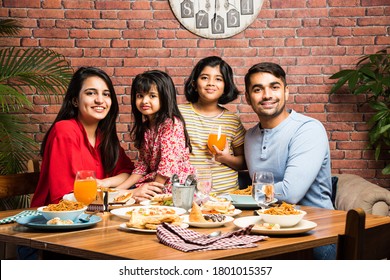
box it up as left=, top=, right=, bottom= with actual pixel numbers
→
left=169, top=0, right=263, bottom=39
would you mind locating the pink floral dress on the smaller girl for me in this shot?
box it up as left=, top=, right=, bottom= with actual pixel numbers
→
left=133, top=118, right=195, bottom=191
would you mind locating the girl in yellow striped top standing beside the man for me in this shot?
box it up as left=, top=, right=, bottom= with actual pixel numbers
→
left=179, top=56, right=245, bottom=193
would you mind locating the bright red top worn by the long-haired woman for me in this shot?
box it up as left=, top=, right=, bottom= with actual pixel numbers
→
left=31, top=119, right=134, bottom=207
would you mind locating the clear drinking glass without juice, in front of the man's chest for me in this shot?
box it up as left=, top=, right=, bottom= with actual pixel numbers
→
left=252, top=171, right=274, bottom=208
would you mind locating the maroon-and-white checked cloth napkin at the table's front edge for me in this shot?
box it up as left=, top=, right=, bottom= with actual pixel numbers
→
left=157, top=223, right=267, bottom=252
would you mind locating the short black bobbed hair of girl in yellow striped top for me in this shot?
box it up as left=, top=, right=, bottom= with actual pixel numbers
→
left=184, top=56, right=240, bottom=104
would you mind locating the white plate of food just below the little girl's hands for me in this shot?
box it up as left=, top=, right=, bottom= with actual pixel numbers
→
left=111, top=205, right=187, bottom=220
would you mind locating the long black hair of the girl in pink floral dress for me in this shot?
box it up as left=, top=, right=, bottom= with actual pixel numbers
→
left=131, top=70, right=192, bottom=151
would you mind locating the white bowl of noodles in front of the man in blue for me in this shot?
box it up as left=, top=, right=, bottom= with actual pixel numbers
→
left=257, top=202, right=306, bottom=228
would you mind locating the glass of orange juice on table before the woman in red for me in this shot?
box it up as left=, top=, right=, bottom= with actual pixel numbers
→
left=73, top=170, right=97, bottom=205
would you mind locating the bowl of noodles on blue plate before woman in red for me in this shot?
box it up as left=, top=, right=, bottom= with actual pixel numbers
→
left=37, top=200, right=87, bottom=221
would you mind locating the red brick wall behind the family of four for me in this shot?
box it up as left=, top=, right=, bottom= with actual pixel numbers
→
left=0, top=0, right=390, bottom=188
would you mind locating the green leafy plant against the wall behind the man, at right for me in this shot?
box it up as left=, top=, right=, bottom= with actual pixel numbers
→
left=330, top=49, right=390, bottom=175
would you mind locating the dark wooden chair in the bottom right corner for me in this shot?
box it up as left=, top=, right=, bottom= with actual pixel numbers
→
left=337, top=208, right=390, bottom=260
